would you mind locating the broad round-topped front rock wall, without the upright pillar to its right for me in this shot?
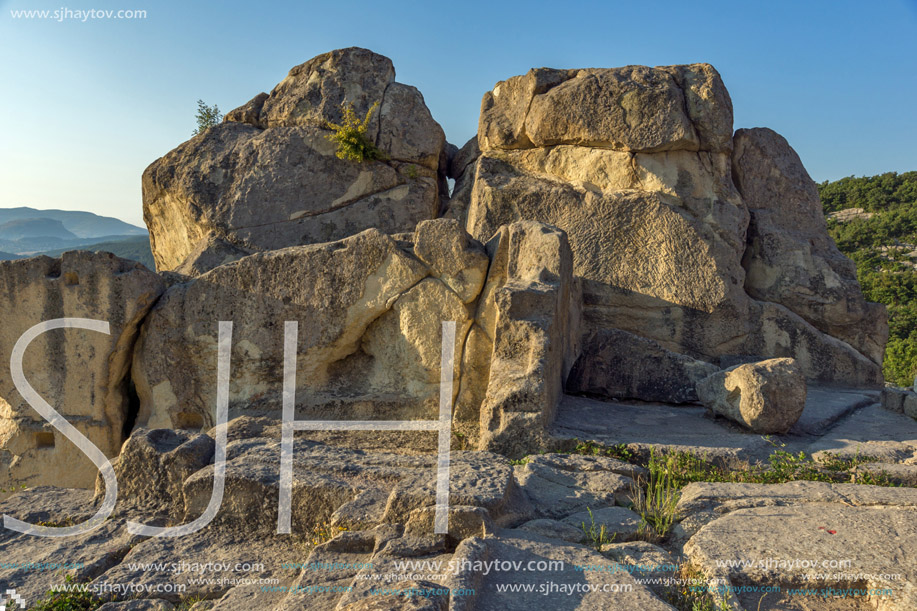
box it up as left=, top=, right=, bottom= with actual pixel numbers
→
left=133, top=229, right=452, bottom=428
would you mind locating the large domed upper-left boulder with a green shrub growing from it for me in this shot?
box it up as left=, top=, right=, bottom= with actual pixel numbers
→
left=143, top=48, right=446, bottom=270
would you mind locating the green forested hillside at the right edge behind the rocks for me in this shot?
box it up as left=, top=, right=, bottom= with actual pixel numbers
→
left=818, top=172, right=917, bottom=386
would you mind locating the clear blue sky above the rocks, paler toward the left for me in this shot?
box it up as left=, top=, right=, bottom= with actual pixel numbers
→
left=0, top=0, right=917, bottom=224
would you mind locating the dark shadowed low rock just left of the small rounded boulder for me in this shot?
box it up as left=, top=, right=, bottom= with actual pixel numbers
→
left=567, top=329, right=718, bottom=403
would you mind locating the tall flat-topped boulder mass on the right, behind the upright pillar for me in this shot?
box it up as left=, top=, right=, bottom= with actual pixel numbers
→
left=458, top=59, right=886, bottom=390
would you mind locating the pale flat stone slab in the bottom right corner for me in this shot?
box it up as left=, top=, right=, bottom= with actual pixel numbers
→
left=684, top=503, right=917, bottom=611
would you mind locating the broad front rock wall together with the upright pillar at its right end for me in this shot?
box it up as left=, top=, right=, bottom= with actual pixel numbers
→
left=133, top=219, right=579, bottom=454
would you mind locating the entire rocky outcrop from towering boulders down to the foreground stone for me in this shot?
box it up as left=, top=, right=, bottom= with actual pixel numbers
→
left=0, top=49, right=904, bottom=611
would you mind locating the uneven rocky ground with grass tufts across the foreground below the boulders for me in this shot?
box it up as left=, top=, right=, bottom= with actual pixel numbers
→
left=0, top=388, right=917, bottom=610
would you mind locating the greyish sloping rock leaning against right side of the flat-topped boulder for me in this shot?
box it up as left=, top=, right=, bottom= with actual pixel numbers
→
left=733, top=128, right=888, bottom=364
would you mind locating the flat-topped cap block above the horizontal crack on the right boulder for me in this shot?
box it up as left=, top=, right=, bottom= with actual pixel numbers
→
left=478, top=64, right=732, bottom=152
